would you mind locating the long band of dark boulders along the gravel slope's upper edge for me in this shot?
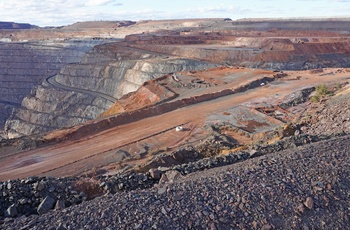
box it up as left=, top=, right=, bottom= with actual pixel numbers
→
left=0, top=130, right=340, bottom=219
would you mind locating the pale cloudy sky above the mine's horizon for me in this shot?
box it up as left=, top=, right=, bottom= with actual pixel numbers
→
left=0, top=0, right=350, bottom=26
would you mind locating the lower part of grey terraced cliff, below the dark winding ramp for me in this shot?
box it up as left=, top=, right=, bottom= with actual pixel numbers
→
left=4, top=83, right=112, bottom=139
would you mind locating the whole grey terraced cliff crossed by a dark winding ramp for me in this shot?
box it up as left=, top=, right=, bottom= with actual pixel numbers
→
left=5, top=41, right=216, bottom=138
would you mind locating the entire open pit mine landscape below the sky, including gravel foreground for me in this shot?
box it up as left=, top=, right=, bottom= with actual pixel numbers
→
left=0, top=18, right=350, bottom=229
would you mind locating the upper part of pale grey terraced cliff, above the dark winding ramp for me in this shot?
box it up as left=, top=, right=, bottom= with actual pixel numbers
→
left=55, top=44, right=214, bottom=99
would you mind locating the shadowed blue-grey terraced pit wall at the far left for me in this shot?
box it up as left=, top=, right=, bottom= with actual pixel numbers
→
left=0, top=40, right=101, bottom=131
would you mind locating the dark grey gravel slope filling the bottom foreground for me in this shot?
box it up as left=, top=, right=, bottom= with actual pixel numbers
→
left=0, top=135, right=350, bottom=229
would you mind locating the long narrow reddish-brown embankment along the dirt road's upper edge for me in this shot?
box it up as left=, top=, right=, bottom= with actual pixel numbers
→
left=58, top=77, right=274, bottom=140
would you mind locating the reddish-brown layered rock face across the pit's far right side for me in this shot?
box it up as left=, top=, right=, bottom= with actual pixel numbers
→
left=126, top=30, right=350, bottom=70
